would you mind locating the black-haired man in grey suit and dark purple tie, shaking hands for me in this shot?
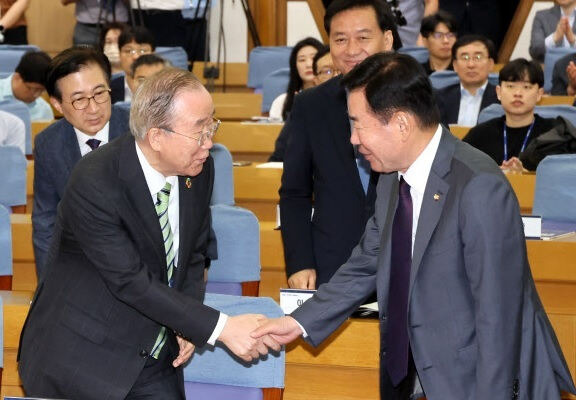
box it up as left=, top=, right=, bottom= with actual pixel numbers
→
left=253, top=54, right=576, bottom=400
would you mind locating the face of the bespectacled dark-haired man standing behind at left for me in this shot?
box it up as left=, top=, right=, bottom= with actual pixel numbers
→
left=50, top=63, right=112, bottom=135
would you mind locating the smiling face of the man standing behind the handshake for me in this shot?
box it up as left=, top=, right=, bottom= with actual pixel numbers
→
left=330, top=7, right=393, bottom=74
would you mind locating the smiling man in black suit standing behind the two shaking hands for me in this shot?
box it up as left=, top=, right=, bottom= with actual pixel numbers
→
left=279, top=0, right=400, bottom=289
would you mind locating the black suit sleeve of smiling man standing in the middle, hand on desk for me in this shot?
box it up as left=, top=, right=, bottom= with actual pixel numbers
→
left=279, top=96, right=318, bottom=276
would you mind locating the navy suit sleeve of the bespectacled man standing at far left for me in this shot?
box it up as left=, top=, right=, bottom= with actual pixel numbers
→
left=32, top=136, right=60, bottom=278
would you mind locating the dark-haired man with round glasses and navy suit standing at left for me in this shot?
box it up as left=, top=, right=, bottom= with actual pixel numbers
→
left=32, top=47, right=128, bottom=278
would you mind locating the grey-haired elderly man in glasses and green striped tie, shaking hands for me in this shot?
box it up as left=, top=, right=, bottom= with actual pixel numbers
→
left=19, top=69, right=279, bottom=400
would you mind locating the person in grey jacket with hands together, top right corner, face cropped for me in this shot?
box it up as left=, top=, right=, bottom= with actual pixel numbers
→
left=529, top=0, right=576, bottom=63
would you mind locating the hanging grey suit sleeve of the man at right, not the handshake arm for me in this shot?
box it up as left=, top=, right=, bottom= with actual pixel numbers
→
left=459, top=174, right=528, bottom=400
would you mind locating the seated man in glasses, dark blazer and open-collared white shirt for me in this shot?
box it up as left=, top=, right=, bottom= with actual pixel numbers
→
left=436, top=35, right=498, bottom=126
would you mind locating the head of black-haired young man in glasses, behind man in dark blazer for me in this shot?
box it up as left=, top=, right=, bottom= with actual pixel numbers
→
left=420, top=11, right=458, bottom=75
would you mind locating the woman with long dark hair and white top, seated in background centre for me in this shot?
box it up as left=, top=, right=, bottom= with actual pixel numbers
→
left=270, top=37, right=323, bottom=121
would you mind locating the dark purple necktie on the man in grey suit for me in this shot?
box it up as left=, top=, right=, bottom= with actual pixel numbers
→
left=386, top=178, right=412, bottom=386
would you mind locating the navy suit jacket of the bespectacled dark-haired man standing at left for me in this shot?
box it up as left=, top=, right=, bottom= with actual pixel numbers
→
left=32, top=107, right=129, bottom=277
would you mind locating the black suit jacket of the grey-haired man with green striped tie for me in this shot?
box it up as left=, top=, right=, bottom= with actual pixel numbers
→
left=19, top=135, right=219, bottom=400
